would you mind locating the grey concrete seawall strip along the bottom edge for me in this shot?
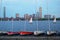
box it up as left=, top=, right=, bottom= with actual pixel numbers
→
left=0, top=36, right=60, bottom=40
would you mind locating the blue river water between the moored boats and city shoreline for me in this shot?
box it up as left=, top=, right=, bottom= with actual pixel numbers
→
left=0, top=20, right=60, bottom=32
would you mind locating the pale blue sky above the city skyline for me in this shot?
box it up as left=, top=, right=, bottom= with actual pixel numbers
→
left=0, top=0, right=60, bottom=17
